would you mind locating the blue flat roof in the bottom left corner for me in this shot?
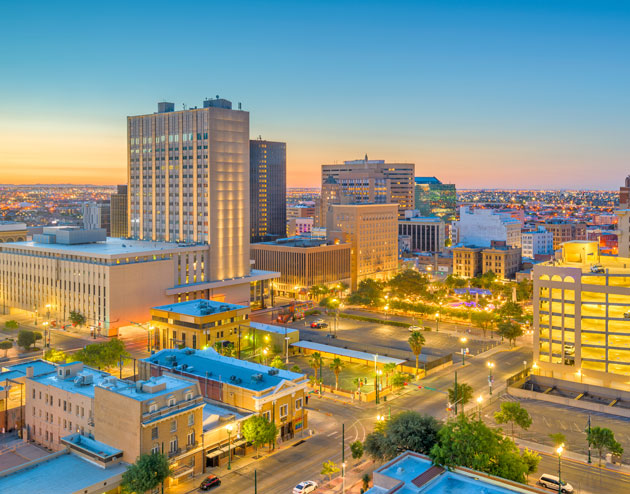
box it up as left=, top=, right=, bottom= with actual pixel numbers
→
left=0, top=454, right=129, bottom=494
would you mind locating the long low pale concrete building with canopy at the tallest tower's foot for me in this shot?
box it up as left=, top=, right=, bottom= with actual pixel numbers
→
left=0, top=228, right=277, bottom=335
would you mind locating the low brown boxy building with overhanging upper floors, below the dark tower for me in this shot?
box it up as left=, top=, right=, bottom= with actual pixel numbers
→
left=250, top=238, right=351, bottom=297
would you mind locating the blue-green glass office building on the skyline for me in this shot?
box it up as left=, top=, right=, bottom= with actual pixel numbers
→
left=414, top=177, right=457, bottom=221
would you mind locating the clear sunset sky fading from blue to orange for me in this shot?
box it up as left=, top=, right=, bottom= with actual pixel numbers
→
left=0, top=0, right=630, bottom=189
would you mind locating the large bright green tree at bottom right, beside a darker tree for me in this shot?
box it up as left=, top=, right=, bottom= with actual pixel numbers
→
left=429, top=414, right=529, bottom=483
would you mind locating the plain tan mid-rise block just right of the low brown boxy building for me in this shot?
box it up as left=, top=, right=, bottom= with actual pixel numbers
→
left=326, top=204, right=398, bottom=290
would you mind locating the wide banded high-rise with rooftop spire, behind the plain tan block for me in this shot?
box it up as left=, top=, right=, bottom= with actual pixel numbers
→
left=322, top=155, right=415, bottom=221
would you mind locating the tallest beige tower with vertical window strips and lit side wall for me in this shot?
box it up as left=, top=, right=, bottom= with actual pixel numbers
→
left=127, top=97, right=250, bottom=280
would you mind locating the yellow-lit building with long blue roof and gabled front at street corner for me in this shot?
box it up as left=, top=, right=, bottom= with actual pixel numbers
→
left=139, top=349, right=308, bottom=439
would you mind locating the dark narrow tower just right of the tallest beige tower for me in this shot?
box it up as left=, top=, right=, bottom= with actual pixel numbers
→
left=249, top=139, right=287, bottom=242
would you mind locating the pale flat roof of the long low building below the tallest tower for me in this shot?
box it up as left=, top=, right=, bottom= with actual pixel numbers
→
left=2, top=237, right=203, bottom=258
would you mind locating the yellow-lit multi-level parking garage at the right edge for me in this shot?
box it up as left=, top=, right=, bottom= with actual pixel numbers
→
left=533, top=241, right=630, bottom=389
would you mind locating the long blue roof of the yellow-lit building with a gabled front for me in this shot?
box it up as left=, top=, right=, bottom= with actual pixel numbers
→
left=143, top=348, right=304, bottom=391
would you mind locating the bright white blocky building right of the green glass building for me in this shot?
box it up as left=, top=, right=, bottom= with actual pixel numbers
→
left=451, top=206, right=521, bottom=247
